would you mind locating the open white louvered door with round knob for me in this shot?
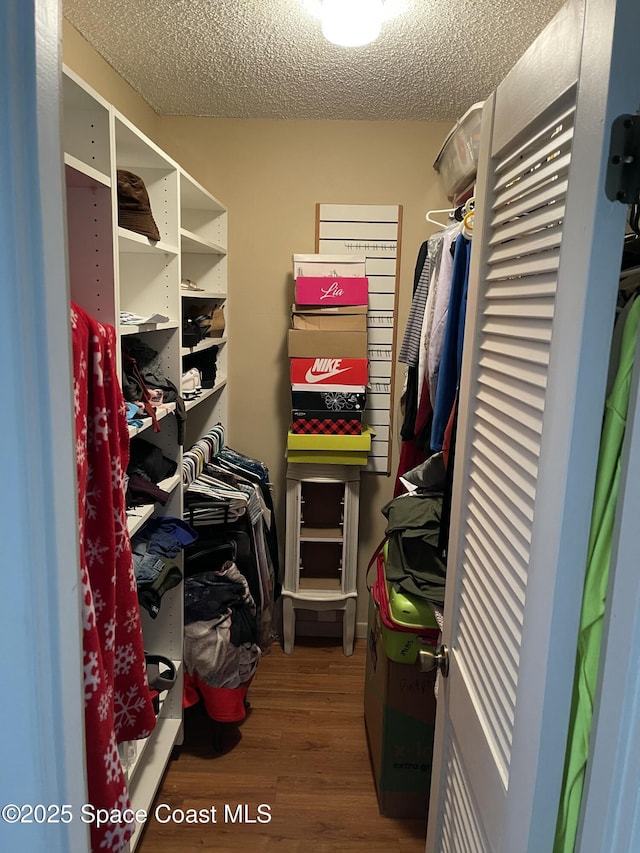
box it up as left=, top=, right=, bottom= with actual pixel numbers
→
left=427, top=0, right=640, bottom=853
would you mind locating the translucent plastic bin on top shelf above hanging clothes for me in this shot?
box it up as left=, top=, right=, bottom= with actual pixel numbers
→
left=433, top=102, right=484, bottom=201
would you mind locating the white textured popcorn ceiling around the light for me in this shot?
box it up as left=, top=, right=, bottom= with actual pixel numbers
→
left=63, top=0, right=562, bottom=121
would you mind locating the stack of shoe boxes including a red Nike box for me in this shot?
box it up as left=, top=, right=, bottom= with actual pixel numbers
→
left=287, top=255, right=371, bottom=464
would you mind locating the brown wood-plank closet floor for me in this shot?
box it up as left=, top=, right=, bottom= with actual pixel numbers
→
left=138, top=638, right=425, bottom=853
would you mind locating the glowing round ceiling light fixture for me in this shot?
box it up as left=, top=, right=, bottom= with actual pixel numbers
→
left=303, top=0, right=407, bottom=47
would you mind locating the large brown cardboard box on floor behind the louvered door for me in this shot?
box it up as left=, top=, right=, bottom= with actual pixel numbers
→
left=364, top=599, right=436, bottom=818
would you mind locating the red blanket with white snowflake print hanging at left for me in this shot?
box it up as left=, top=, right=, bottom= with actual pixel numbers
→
left=71, top=304, right=155, bottom=853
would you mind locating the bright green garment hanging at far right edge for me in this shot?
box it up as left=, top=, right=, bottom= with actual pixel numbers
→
left=553, top=297, right=640, bottom=853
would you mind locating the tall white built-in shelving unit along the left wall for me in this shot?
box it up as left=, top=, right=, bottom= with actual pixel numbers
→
left=63, top=68, right=228, bottom=850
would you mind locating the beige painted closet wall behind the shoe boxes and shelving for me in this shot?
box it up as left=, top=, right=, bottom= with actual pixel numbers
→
left=63, top=24, right=450, bottom=622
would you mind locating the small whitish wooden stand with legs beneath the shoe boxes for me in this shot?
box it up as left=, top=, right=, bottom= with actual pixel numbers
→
left=282, top=464, right=360, bottom=655
